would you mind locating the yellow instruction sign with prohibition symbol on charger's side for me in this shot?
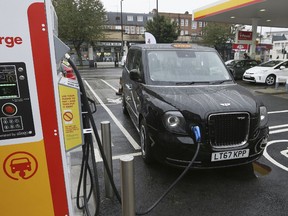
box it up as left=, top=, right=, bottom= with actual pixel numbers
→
left=59, top=77, right=83, bottom=151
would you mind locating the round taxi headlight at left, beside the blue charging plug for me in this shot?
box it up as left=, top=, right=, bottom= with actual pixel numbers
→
left=162, top=111, right=186, bottom=134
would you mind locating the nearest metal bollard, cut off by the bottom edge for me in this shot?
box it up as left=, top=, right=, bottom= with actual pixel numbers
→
left=120, top=156, right=135, bottom=216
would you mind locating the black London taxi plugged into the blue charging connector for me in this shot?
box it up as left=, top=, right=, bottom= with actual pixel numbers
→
left=122, top=44, right=269, bottom=168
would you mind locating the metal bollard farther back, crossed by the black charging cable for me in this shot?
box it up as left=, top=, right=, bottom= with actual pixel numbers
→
left=101, top=121, right=114, bottom=199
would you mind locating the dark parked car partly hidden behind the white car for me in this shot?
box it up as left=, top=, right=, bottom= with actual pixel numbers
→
left=225, top=59, right=261, bottom=79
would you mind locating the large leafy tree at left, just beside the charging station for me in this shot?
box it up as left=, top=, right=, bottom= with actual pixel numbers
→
left=53, top=0, right=106, bottom=65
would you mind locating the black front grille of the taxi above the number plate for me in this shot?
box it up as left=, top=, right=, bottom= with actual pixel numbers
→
left=208, top=112, right=250, bottom=148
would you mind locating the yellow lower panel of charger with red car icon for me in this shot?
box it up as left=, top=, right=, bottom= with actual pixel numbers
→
left=0, top=140, right=54, bottom=216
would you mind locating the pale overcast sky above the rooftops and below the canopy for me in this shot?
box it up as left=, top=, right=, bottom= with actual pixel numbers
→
left=100, top=0, right=287, bottom=34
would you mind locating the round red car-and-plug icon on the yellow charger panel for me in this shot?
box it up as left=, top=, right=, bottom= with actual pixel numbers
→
left=3, top=152, right=38, bottom=180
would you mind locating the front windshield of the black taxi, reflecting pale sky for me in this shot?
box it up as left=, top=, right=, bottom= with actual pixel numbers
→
left=147, top=49, right=231, bottom=85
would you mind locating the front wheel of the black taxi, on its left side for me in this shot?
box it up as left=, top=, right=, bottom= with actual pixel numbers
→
left=140, top=119, right=154, bottom=164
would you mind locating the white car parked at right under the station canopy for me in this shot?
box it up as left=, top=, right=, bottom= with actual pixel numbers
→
left=242, top=59, right=288, bottom=85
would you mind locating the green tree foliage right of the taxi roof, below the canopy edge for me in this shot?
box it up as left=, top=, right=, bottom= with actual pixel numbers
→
left=203, top=22, right=234, bottom=49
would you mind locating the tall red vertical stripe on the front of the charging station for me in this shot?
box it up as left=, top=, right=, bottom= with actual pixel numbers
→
left=28, top=3, right=68, bottom=216
